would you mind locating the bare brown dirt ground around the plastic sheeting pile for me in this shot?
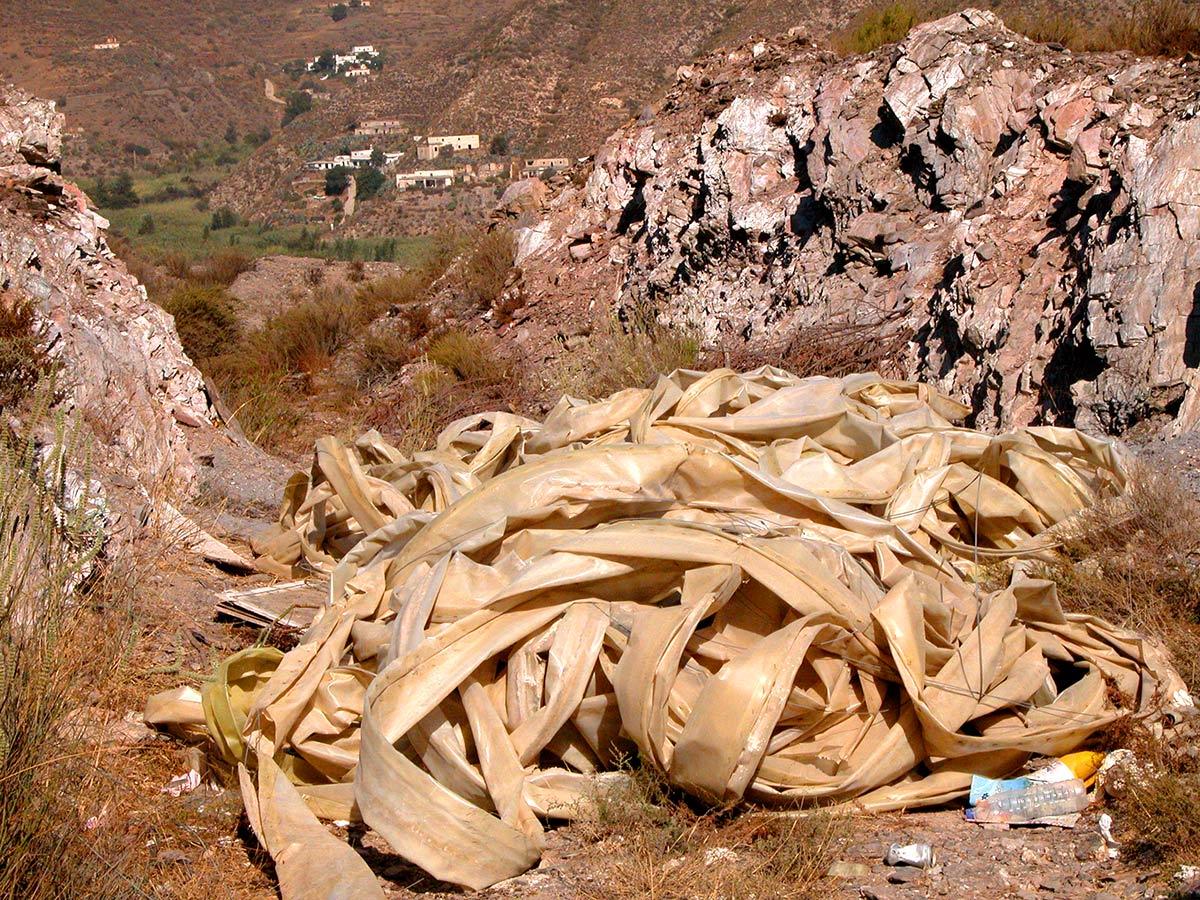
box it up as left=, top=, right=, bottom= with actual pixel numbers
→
left=102, top=437, right=1200, bottom=900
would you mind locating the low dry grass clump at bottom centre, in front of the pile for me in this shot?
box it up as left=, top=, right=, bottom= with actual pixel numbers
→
left=581, top=767, right=850, bottom=900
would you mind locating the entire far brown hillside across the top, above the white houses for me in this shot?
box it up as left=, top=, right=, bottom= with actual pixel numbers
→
left=0, top=0, right=856, bottom=180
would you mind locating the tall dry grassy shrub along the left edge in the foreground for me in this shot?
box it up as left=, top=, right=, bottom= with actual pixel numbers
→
left=0, top=394, right=140, bottom=900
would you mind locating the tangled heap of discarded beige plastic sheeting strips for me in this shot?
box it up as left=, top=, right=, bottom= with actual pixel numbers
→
left=148, top=368, right=1182, bottom=896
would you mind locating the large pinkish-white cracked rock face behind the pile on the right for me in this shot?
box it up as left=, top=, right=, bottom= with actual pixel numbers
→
left=516, top=10, right=1200, bottom=432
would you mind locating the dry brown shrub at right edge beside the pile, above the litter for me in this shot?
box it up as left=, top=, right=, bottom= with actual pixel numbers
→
left=1045, top=462, right=1200, bottom=691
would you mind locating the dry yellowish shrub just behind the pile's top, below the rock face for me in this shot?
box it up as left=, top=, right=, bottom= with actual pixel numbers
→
left=548, top=323, right=700, bottom=400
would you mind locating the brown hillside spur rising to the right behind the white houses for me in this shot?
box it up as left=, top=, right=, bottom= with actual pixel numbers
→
left=216, top=0, right=859, bottom=218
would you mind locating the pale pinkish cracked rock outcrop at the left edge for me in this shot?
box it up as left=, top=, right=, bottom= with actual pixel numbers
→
left=0, top=85, right=210, bottom=496
